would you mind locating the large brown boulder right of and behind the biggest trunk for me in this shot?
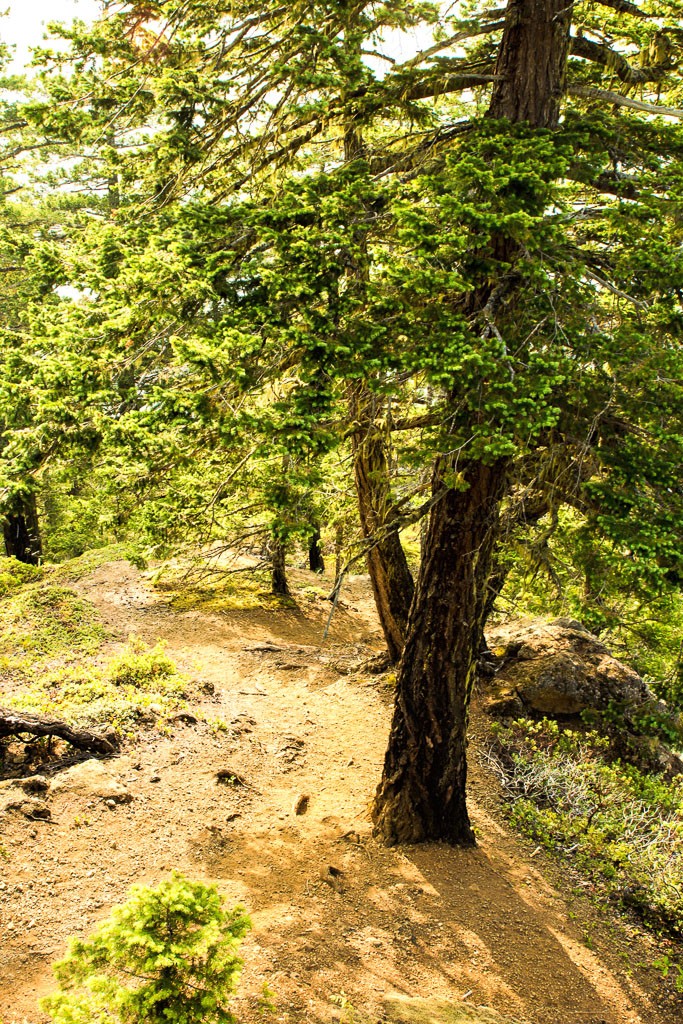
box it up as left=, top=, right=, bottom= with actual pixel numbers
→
left=484, top=618, right=656, bottom=717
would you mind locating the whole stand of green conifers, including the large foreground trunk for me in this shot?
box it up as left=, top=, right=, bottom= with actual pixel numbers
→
left=0, top=0, right=683, bottom=843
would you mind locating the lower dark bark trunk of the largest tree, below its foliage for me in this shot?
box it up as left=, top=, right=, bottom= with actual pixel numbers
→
left=374, top=461, right=507, bottom=845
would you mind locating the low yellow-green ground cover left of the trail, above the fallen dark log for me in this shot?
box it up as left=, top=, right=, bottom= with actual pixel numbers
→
left=0, top=557, right=197, bottom=736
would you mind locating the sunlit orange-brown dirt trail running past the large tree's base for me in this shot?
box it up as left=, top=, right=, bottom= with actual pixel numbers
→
left=0, top=562, right=681, bottom=1024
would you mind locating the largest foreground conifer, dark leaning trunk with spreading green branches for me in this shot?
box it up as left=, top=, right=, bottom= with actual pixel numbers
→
left=15, top=0, right=683, bottom=843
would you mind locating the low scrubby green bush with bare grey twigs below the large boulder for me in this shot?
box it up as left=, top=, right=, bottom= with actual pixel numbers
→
left=487, top=719, right=683, bottom=936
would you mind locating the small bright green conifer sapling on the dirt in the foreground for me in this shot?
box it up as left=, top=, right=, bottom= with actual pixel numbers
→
left=41, top=871, right=251, bottom=1024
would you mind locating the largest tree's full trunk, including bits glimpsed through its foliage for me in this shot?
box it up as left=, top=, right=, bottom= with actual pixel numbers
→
left=374, top=0, right=680, bottom=843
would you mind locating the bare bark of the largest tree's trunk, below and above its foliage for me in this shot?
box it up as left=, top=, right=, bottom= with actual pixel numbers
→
left=373, top=0, right=571, bottom=845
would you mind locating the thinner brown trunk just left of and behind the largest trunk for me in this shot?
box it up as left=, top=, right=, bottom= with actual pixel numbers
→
left=353, top=422, right=415, bottom=664
